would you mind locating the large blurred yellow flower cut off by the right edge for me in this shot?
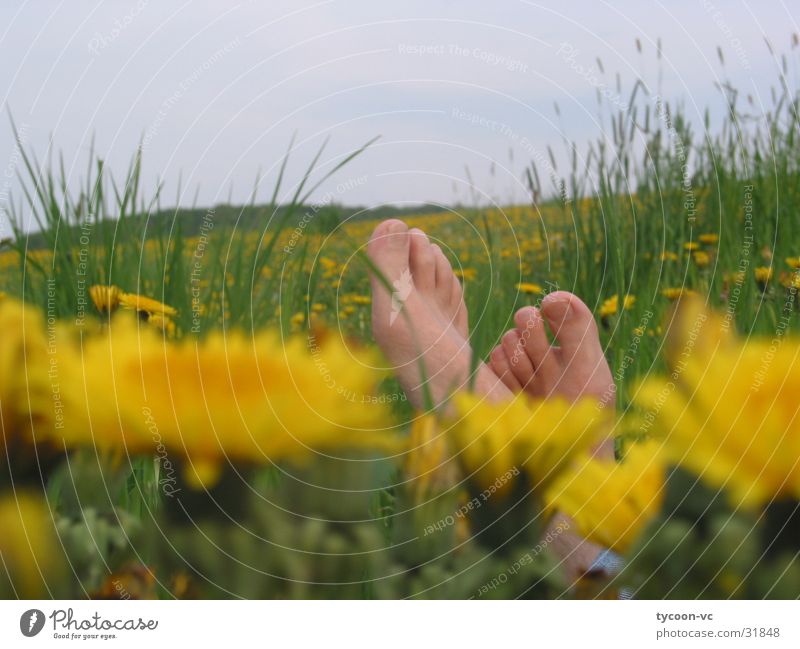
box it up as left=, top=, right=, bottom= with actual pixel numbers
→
left=635, top=300, right=800, bottom=509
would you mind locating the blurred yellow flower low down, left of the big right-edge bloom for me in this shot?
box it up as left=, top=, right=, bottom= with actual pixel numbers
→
left=545, top=442, right=665, bottom=552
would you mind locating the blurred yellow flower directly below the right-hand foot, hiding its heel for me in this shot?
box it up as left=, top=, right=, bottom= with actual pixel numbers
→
left=449, top=394, right=612, bottom=488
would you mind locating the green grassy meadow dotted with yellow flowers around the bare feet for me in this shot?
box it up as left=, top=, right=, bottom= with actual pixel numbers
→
left=0, top=53, right=800, bottom=598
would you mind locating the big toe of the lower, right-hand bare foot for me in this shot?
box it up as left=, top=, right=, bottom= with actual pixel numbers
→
left=542, top=291, right=603, bottom=365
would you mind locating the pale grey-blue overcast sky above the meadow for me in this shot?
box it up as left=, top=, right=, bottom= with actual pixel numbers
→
left=0, top=0, right=800, bottom=228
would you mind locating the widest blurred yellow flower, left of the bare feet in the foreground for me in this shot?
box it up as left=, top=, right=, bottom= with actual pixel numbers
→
left=56, top=319, right=394, bottom=486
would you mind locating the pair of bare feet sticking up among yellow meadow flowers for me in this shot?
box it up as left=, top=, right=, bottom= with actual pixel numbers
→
left=367, top=219, right=614, bottom=579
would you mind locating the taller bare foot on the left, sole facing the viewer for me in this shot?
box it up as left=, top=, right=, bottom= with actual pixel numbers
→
left=367, top=219, right=511, bottom=408
